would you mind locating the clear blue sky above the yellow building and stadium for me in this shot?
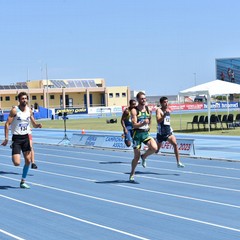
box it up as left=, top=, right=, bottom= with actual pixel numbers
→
left=0, top=0, right=240, bottom=96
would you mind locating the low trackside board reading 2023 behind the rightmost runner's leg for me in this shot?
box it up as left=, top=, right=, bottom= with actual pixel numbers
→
left=160, top=138, right=195, bottom=155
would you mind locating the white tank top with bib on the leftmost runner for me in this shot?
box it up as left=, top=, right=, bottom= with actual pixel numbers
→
left=11, top=106, right=30, bottom=135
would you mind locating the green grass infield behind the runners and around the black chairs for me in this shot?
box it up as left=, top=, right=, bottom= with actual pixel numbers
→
left=0, top=112, right=240, bottom=136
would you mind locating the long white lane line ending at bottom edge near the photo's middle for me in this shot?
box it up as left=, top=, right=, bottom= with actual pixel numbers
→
left=0, top=194, right=149, bottom=240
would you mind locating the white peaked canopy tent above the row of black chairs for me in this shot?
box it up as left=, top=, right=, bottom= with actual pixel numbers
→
left=178, top=80, right=240, bottom=131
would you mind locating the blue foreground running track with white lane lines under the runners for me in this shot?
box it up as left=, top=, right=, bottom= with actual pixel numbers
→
left=0, top=144, right=240, bottom=240
